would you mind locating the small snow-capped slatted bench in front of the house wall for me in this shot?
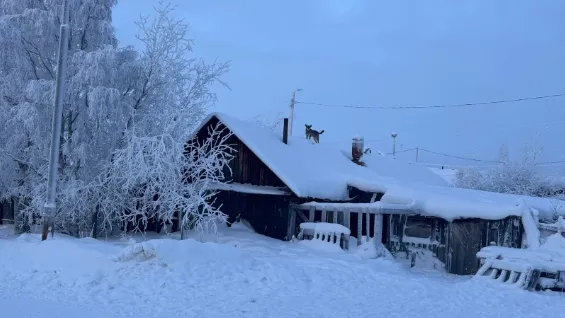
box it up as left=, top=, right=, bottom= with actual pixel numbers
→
left=298, top=222, right=351, bottom=249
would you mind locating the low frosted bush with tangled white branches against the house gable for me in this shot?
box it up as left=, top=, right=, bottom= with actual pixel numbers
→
left=100, top=124, right=232, bottom=237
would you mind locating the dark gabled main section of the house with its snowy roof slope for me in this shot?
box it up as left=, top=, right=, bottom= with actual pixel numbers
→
left=187, top=113, right=390, bottom=240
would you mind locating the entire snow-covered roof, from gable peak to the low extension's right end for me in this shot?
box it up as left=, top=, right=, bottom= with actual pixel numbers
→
left=196, top=113, right=565, bottom=220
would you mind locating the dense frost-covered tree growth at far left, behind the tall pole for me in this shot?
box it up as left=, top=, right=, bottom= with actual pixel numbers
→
left=0, top=0, right=123, bottom=224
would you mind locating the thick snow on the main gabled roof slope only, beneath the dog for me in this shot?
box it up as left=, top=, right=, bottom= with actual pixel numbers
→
left=196, top=113, right=396, bottom=200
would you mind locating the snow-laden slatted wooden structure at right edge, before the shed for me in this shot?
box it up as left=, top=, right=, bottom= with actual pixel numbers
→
left=475, top=246, right=565, bottom=290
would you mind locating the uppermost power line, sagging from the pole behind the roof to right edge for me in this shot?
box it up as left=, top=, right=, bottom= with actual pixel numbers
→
left=296, top=93, right=565, bottom=110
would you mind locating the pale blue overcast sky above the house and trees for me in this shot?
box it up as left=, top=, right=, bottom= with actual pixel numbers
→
left=113, top=0, right=565, bottom=169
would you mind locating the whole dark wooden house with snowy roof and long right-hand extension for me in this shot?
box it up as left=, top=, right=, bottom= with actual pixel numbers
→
left=195, top=113, right=564, bottom=275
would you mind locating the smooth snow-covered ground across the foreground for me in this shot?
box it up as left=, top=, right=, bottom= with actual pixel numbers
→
left=0, top=225, right=565, bottom=318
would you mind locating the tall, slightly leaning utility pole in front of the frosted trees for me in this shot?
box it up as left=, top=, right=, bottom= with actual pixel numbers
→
left=41, top=0, right=69, bottom=241
